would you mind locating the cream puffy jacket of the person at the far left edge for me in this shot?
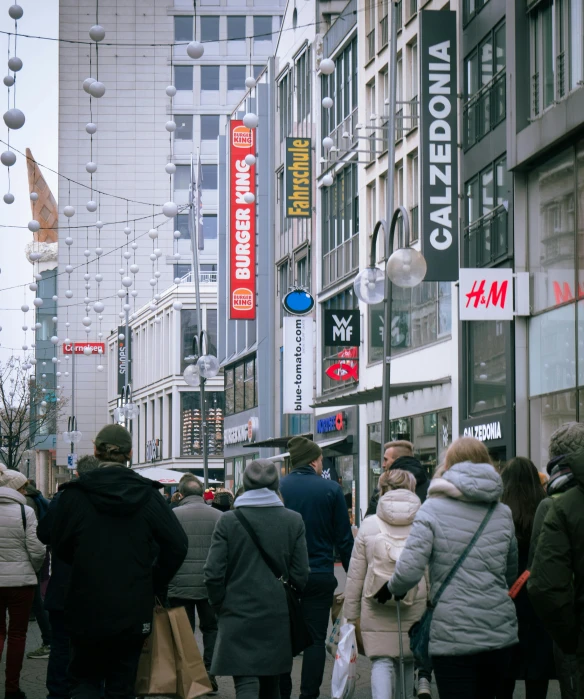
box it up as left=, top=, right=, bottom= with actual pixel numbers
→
left=0, top=488, right=45, bottom=587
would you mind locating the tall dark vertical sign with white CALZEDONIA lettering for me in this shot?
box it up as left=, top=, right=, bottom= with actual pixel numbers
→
left=420, top=10, right=459, bottom=282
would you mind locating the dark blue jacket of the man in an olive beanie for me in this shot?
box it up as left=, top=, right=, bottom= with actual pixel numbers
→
left=280, top=465, right=354, bottom=573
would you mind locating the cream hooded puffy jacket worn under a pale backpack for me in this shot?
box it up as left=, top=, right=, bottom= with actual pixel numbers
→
left=343, top=490, right=427, bottom=658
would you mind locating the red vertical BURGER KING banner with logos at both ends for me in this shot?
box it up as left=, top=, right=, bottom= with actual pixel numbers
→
left=229, top=120, right=256, bottom=320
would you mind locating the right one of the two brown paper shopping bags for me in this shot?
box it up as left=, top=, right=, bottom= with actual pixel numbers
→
left=166, top=607, right=213, bottom=699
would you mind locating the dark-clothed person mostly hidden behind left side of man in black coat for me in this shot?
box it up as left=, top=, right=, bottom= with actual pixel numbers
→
left=37, top=455, right=100, bottom=699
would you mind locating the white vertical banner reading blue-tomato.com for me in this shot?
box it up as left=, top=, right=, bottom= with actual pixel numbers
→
left=282, top=316, right=314, bottom=414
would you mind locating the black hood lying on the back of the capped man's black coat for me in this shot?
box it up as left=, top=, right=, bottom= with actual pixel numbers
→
left=63, top=462, right=163, bottom=517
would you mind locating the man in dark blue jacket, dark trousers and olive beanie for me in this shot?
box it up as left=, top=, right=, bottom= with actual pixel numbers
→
left=280, top=437, right=353, bottom=699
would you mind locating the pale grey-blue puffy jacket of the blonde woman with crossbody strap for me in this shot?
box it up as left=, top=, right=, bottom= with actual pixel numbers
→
left=389, top=462, right=518, bottom=655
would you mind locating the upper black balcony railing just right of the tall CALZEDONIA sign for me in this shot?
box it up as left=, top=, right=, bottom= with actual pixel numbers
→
left=464, top=71, right=507, bottom=148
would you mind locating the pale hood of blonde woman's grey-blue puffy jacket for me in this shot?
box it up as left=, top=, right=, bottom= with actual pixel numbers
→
left=428, top=461, right=503, bottom=502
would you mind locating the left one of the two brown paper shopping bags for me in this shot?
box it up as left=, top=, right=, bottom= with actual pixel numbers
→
left=136, top=607, right=176, bottom=696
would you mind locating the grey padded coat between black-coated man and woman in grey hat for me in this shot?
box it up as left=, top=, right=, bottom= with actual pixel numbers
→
left=168, top=495, right=221, bottom=599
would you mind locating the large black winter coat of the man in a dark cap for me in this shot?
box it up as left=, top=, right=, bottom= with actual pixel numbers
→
left=51, top=463, right=188, bottom=638
